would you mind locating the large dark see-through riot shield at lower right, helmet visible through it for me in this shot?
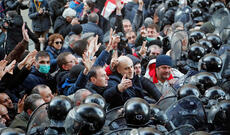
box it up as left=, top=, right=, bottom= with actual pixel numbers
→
left=165, top=96, right=207, bottom=129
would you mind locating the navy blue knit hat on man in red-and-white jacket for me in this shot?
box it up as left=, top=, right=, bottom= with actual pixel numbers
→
left=156, top=55, right=172, bottom=67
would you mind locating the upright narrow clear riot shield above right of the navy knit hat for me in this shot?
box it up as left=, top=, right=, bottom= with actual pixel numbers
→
left=170, top=30, right=188, bottom=66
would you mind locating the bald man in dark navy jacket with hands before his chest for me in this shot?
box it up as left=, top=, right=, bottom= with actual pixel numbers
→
left=103, top=56, right=161, bottom=107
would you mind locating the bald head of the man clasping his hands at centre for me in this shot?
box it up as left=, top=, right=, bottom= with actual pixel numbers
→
left=117, top=56, right=134, bottom=79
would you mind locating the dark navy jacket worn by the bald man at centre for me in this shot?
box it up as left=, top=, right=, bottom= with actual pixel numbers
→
left=103, top=73, right=161, bottom=108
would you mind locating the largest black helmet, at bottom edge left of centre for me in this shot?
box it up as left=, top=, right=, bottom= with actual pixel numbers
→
left=65, top=103, right=105, bottom=135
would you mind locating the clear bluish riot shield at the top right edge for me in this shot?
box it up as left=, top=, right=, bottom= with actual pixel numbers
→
left=210, top=8, right=230, bottom=35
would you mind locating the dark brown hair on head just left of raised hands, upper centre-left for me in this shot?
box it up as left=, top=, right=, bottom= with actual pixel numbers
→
left=73, top=40, right=88, bottom=56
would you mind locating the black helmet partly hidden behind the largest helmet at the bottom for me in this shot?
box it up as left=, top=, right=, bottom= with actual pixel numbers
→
left=83, top=94, right=106, bottom=109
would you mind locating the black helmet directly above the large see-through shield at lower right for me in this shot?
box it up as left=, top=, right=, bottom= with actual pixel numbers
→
left=178, top=84, right=200, bottom=99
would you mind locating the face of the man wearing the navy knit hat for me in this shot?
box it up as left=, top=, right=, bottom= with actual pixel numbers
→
left=156, top=65, right=171, bottom=81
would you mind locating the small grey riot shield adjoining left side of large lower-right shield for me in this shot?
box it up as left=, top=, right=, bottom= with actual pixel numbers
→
left=156, top=96, right=177, bottom=110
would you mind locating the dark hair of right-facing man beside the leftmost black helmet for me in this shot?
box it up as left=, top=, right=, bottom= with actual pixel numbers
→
left=24, top=94, right=42, bottom=112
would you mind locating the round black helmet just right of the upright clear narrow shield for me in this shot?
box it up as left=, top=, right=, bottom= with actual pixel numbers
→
left=188, top=43, right=205, bottom=62
